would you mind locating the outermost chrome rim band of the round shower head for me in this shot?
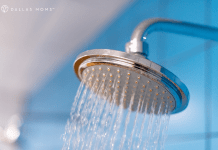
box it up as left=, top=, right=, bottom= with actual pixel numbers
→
left=74, top=49, right=189, bottom=113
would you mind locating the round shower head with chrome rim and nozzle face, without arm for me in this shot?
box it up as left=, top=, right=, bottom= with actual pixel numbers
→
left=74, top=49, right=189, bottom=114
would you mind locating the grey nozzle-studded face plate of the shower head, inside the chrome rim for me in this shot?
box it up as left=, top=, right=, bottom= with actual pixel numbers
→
left=82, top=65, right=176, bottom=114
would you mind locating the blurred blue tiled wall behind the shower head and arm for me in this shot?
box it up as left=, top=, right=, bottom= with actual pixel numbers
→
left=7, top=0, right=218, bottom=150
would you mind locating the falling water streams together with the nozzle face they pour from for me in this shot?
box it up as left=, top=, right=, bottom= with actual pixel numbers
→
left=62, top=66, right=172, bottom=150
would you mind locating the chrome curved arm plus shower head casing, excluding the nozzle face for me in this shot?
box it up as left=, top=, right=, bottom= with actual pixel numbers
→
left=74, top=18, right=218, bottom=113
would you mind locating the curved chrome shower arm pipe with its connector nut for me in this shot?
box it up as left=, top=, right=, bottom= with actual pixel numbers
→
left=126, top=18, right=218, bottom=57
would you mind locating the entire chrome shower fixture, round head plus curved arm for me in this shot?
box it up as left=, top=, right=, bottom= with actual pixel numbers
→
left=74, top=18, right=218, bottom=114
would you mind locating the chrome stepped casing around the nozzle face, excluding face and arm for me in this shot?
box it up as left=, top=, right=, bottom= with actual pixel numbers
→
left=74, top=49, right=189, bottom=113
